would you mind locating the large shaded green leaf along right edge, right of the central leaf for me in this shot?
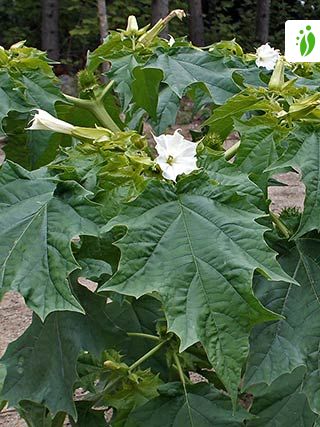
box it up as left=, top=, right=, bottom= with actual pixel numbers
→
left=244, top=238, right=320, bottom=414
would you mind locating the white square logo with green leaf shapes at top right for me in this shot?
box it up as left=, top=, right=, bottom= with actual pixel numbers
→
left=285, top=20, right=320, bottom=62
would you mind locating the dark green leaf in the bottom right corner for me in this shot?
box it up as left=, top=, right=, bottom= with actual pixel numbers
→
left=247, top=368, right=317, bottom=427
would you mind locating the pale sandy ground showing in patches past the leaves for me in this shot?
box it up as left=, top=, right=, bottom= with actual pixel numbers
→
left=0, top=142, right=304, bottom=427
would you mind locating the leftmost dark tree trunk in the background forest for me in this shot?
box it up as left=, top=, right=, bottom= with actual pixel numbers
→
left=41, top=0, right=60, bottom=60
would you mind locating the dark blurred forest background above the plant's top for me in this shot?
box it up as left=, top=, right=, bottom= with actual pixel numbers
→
left=0, top=0, right=320, bottom=72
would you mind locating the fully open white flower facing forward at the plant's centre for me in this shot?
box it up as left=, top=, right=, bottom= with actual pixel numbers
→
left=154, top=130, right=198, bottom=181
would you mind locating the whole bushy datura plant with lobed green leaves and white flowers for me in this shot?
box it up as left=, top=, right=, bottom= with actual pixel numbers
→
left=0, top=10, right=320, bottom=427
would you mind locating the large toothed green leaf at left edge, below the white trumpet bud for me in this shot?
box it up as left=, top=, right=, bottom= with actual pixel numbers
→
left=0, top=162, right=98, bottom=319
